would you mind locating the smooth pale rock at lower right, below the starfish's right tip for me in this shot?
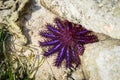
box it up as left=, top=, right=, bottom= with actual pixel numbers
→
left=82, top=38, right=120, bottom=80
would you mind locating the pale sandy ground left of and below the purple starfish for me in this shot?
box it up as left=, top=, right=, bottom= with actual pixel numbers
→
left=22, top=1, right=84, bottom=80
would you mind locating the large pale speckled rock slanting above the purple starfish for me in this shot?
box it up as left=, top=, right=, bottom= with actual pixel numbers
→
left=40, top=0, right=120, bottom=39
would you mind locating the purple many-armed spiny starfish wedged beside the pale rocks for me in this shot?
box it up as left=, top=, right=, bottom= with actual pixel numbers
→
left=39, top=18, right=98, bottom=68
